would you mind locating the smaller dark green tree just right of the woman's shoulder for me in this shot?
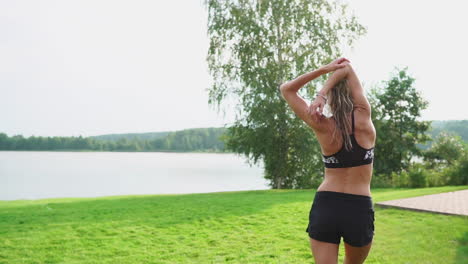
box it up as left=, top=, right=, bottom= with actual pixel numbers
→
left=370, top=68, right=430, bottom=175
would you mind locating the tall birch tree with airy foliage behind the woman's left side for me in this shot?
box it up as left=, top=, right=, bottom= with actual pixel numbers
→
left=205, top=0, right=365, bottom=189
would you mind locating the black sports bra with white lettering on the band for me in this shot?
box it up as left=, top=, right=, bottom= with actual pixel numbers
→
left=322, top=109, right=374, bottom=168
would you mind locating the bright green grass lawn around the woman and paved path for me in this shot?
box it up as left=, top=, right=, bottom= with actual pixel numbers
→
left=0, top=186, right=468, bottom=264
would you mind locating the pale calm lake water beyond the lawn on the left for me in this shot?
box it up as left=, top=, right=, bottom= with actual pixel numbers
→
left=0, top=151, right=269, bottom=200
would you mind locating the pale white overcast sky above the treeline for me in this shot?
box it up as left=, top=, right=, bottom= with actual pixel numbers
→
left=0, top=0, right=468, bottom=136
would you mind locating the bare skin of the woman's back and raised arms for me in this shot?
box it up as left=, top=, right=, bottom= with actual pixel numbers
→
left=280, top=58, right=376, bottom=196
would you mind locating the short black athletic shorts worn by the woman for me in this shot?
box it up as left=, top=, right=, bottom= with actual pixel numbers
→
left=306, top=191, right=374, bottom=247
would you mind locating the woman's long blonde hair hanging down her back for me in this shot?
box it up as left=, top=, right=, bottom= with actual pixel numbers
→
left=328, top=78, right=354, bottom=150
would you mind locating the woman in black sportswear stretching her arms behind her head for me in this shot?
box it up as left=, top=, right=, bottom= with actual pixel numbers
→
left=280, top=58, right=376, bottom=264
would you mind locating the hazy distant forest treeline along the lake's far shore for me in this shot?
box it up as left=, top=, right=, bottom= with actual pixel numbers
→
left=0, top=120, right=468, bottom=152
